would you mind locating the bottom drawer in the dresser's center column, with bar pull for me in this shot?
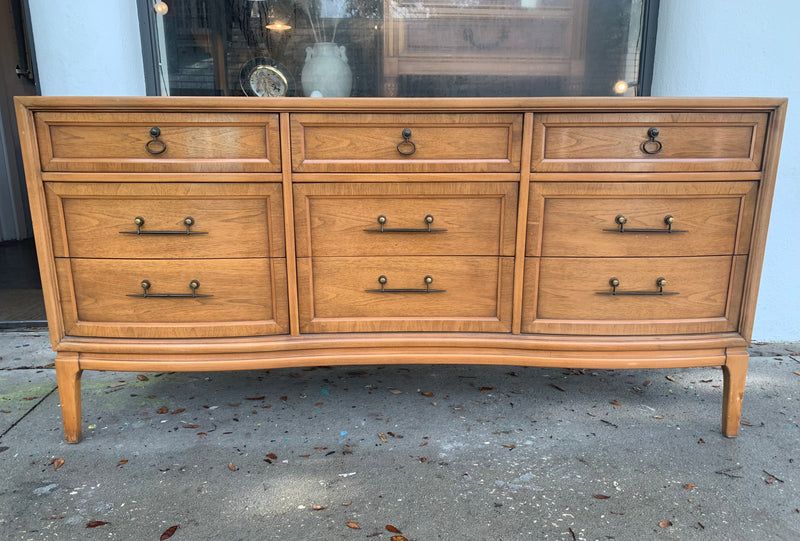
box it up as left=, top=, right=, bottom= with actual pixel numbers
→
left=297, top=257, right=514, bottom=332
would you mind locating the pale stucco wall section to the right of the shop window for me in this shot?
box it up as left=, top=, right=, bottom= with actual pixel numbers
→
left=652, top=0, right=800, bottom=341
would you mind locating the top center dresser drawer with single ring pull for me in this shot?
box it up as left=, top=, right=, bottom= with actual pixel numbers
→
left=291, top=113, right=522, bottom=173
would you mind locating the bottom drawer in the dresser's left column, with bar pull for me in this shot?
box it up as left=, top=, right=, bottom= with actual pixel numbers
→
left=56, top=259, right=289, bottom=338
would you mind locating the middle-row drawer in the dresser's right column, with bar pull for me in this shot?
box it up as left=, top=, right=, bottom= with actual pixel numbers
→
left=526, top=182, right=758, bottom=257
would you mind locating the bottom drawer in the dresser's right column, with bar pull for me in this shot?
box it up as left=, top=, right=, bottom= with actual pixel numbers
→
left=523, top=256, right=747, bottom=335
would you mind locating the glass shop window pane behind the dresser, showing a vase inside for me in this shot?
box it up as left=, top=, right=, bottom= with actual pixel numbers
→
left=155, top=0, right=645, bottom=96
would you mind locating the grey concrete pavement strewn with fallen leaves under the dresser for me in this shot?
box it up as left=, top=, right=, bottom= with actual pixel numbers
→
left=0, top=331, right=800, bottom=541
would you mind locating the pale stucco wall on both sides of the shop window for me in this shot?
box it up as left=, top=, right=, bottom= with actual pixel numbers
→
left=21, top=0, right=800, bottom=341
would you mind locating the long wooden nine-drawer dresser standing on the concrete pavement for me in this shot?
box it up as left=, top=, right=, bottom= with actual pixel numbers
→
left=17, top=97, right=786, bottom=442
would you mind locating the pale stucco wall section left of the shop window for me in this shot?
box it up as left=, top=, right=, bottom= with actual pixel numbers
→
left=28, top=0, right=145, bottom=96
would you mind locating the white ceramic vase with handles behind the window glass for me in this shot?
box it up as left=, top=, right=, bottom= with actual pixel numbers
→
left=300, top=43, right=353, bottom=98
